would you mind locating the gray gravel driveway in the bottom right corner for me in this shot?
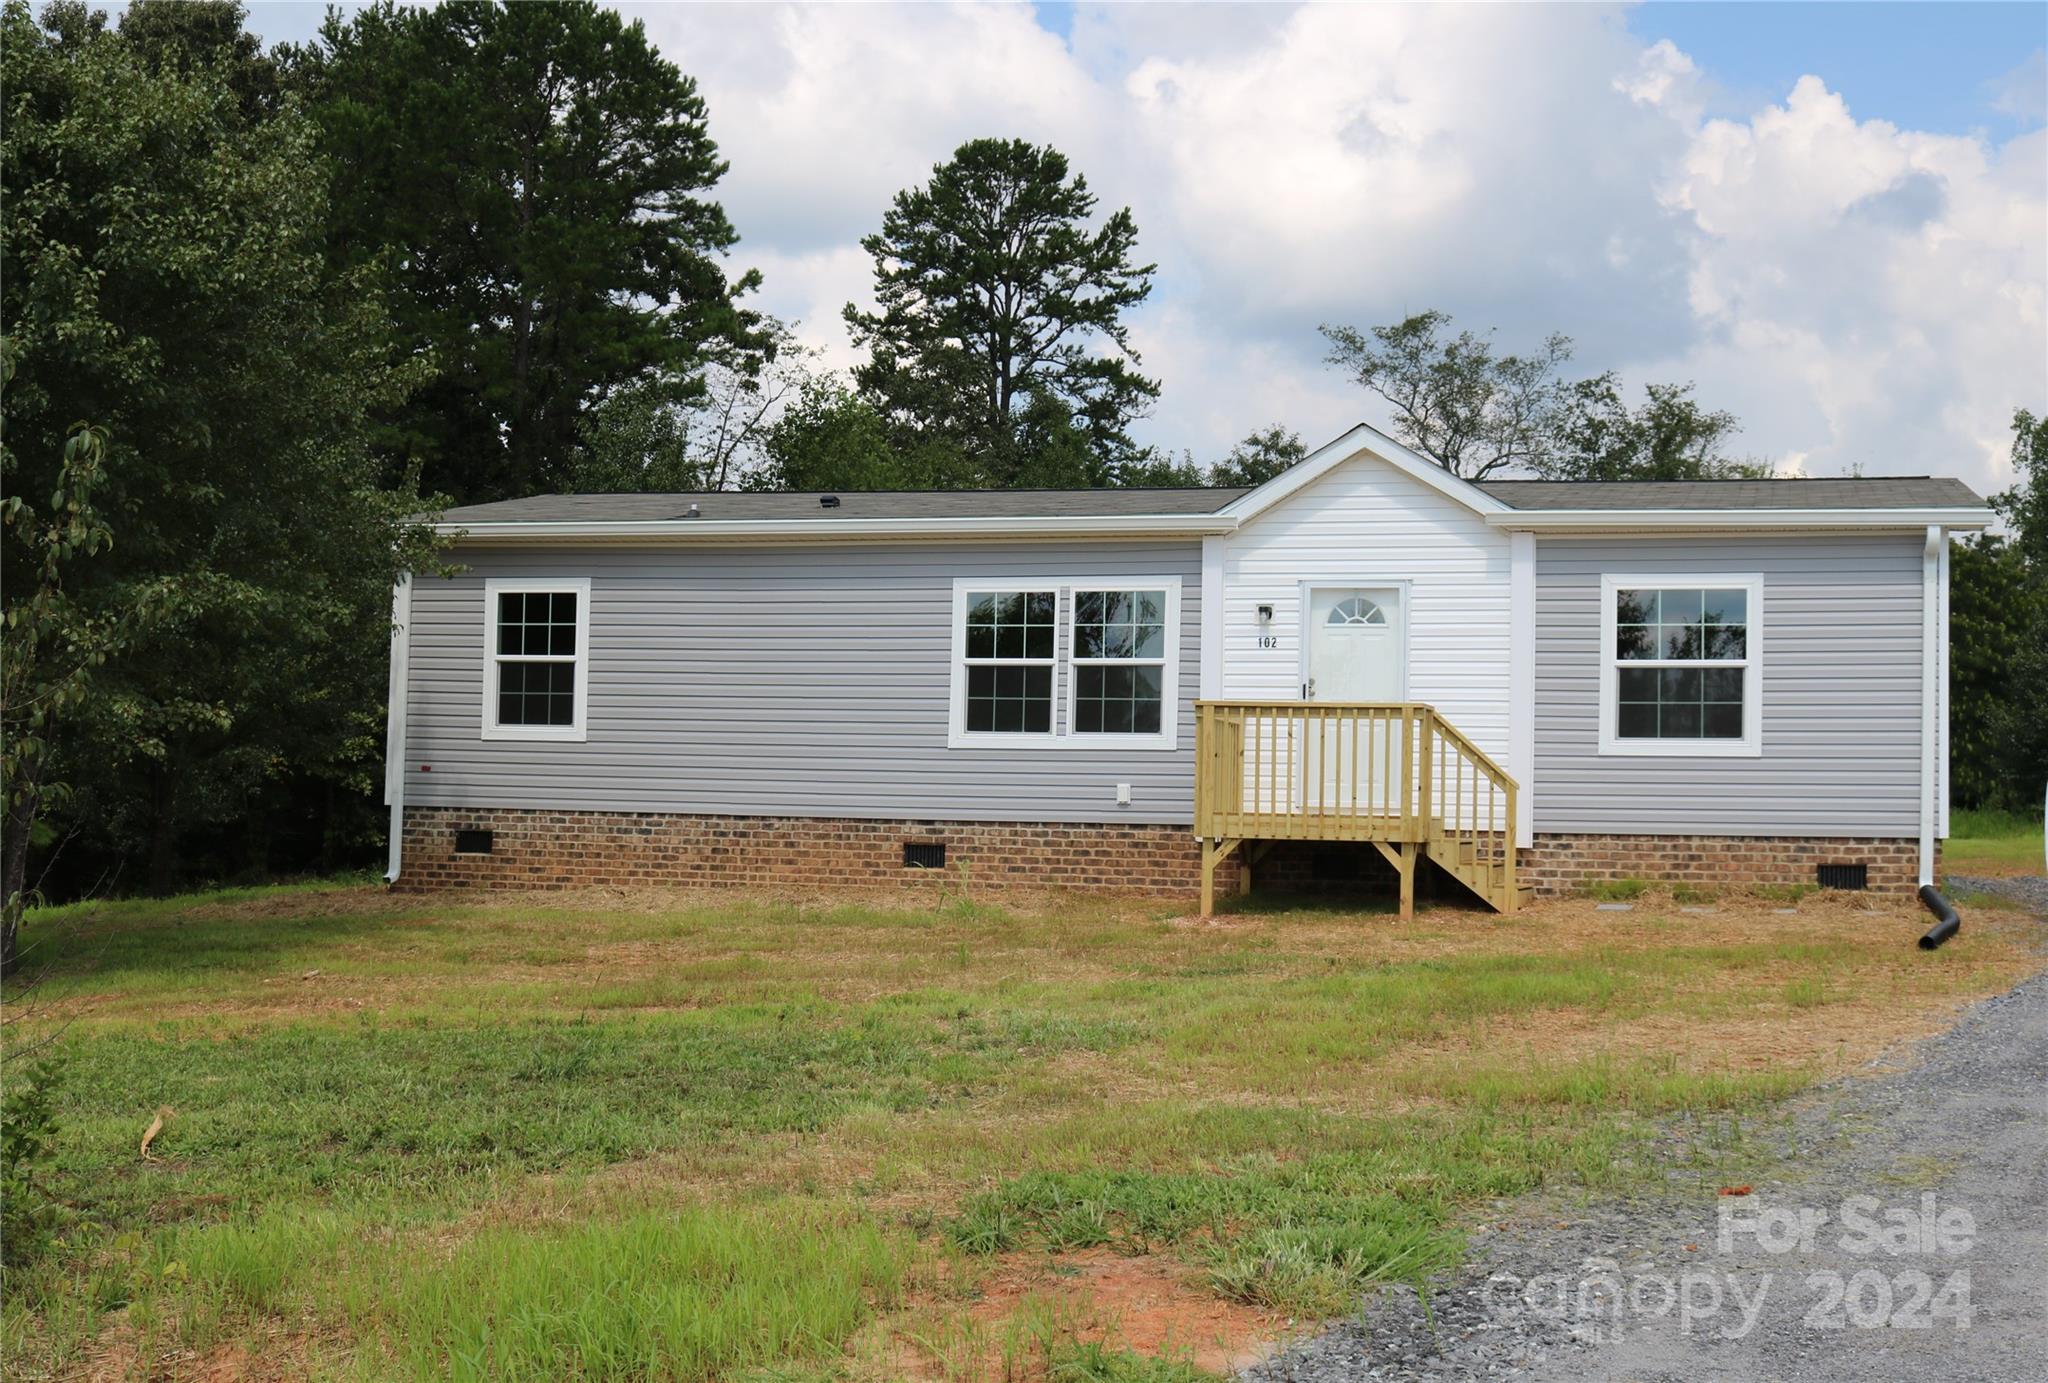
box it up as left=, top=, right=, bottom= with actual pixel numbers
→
left=1241, top=881, right=2048, bottom=1383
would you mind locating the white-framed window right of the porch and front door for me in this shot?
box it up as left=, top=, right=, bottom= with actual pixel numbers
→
left=1599, top=576, right=1763, bottom=756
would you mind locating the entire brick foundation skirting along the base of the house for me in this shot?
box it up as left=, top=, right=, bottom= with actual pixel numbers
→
left=397, top=807, right=1919, bottom=897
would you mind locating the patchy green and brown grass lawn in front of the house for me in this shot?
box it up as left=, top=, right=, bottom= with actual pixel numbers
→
left=0, top=885, right=2036, bottom=1381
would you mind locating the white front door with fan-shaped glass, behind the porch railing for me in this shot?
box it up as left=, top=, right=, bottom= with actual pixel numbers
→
left=1300, top=586, right=1407, bottom=813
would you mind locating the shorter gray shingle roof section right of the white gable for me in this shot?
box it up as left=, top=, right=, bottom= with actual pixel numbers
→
left=1479, top=475, right=1982, bottom=510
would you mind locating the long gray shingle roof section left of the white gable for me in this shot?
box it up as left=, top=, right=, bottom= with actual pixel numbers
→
left=442, top=486, right=1249, bottom=522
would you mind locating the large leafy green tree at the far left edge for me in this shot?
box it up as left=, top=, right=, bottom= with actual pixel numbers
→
left=0, top=0, right=426, bottom=897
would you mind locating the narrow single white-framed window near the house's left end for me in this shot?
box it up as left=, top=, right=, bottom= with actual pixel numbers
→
left=483, top=580, right=590, bottom=740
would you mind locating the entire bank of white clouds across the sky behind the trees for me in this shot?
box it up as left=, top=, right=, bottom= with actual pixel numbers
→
left=641, top=6, right=2048, bottom=486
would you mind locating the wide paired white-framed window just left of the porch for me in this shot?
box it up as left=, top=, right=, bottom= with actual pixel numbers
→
left=948, top=578, right=1180, bottom=748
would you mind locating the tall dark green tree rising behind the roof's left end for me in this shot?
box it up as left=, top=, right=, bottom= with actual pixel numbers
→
left=297, top=0, right=766, bottom=502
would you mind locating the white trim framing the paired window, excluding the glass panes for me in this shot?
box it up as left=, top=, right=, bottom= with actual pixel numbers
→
left=946, top=576, right=1180, bottom=750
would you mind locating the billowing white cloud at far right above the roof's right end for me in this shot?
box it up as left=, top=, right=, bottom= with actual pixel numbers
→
left=1647, top=76, right=2048, bottom=488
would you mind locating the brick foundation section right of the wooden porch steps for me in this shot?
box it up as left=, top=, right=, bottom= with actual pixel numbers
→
left=1516, top=832, right=1939, bottom=893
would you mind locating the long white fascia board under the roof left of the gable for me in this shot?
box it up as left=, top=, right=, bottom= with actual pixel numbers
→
left=434, top=514, right=1237, bottom=543
